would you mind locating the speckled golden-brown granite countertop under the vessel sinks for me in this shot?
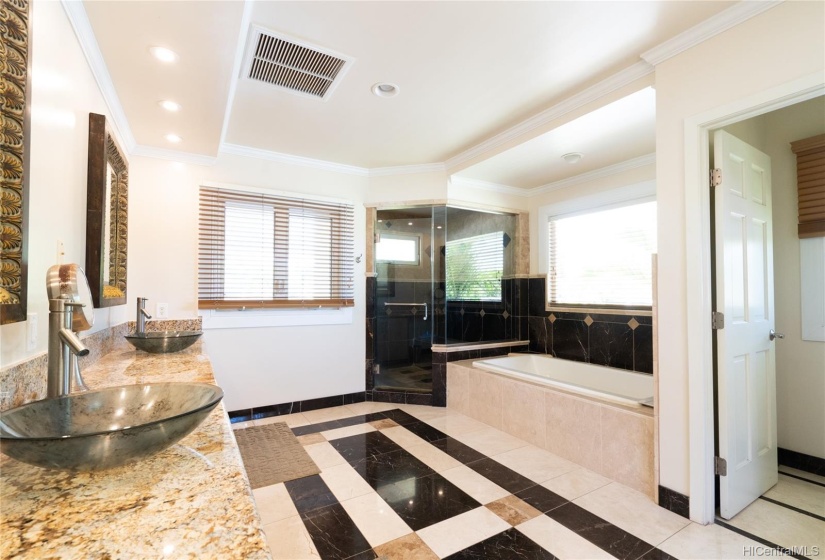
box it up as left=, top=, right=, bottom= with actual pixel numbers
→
left=0, top=342, right=271, bottom=559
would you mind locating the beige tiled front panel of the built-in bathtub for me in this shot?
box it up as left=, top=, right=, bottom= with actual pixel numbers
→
left=447, top=360, right=656, bottom=499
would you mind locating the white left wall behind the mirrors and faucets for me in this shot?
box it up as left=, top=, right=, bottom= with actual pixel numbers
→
left=0, top=2, right=127, bottom=368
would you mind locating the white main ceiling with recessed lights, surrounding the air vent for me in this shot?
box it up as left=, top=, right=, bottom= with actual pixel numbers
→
left=84, top=0, right=735, bottom=170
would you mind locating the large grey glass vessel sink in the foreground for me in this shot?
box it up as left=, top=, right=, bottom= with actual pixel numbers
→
left=0, top=383, right=223, bottom=471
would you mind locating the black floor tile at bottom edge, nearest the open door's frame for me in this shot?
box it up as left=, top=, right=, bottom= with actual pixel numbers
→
left=545, top=503, right=654, bottom=560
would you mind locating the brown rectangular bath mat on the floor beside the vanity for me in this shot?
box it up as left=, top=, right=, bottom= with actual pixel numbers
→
left=235, top=422, right=321, bottom=490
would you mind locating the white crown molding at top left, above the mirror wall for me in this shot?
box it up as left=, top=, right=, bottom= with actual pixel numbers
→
left=60, top=0, right=137, bottom=153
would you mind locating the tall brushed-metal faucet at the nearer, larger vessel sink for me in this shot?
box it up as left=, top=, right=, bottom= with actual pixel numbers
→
left=46, top=299, right=89, bottom=398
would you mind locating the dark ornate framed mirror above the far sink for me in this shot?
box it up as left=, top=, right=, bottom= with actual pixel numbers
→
left=86, top=113, right=129, bottom=307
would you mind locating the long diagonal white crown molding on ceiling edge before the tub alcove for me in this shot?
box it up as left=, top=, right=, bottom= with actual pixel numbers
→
left=446, top=60, right=653, bottom=170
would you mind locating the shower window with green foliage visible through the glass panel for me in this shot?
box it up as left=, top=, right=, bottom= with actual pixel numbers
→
left=446, top=231, right=504, bottom=301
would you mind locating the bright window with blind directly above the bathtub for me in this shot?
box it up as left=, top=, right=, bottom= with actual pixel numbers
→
left=547, top=202, right=656, bottom=308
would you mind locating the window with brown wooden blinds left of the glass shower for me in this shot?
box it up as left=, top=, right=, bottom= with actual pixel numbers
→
left=198, top=187, right=355, bottom=309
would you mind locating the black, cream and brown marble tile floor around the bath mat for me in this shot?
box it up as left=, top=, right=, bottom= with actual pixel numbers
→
left=234, top=402, right=824, bottom=560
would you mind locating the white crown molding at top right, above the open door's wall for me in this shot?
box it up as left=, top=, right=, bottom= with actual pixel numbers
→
left=641, top=0, right=784, bottom=66
